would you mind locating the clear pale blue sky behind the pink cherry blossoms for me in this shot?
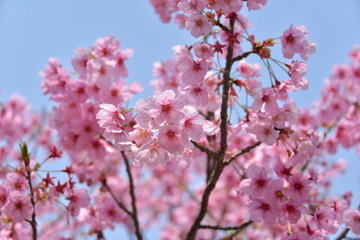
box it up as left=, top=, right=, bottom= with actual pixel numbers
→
left=0, top=0, right=360, bottom=238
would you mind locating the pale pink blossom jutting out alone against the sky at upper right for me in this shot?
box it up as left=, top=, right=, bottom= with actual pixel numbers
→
left=281, top=25, right=316, bottom=60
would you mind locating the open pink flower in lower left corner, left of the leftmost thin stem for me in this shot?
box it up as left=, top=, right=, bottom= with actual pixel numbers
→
left=4, top=191, right=34, bottom=222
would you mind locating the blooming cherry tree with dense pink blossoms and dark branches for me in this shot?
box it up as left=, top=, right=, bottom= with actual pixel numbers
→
left=0, top=0, right=360, bottom=240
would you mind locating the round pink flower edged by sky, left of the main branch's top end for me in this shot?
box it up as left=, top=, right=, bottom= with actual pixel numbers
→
left=185, top=13, right=211, bottom=37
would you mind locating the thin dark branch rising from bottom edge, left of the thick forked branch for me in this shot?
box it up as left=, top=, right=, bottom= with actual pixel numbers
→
left=121, top=151, right=143, bottom=240
